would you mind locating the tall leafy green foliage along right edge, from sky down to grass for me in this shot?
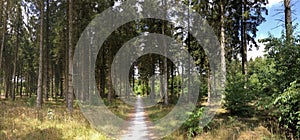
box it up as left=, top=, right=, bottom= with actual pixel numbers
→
left=261, top=29, right=300, bottom=138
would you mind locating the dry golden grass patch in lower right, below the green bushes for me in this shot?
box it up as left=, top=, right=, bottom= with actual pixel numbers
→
left=195, top=116, right=284, bottom=140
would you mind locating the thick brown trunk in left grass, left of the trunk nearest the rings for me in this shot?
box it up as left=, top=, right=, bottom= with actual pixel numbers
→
left=36, top=0, right=44, bottom=109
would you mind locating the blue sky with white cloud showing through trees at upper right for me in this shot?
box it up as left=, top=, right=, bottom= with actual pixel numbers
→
left=248, top=0, right=300, bottom=60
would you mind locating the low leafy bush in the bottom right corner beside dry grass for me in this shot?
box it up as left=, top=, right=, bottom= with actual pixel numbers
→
left=273, top=81, right=300, bottom=138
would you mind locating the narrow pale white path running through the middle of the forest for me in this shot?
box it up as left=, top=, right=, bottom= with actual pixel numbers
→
left=121, top=97, right=154, bottom=140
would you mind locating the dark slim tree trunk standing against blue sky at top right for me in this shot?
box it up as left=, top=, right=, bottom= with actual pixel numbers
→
left=284, top=0, right=293, bottom=44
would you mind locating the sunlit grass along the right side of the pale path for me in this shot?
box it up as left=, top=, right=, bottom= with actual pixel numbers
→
left=146, top=101, right=286, bottom=140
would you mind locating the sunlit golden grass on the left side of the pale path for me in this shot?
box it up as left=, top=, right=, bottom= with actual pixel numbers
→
left=0, top=98, right=131, bottom=140
